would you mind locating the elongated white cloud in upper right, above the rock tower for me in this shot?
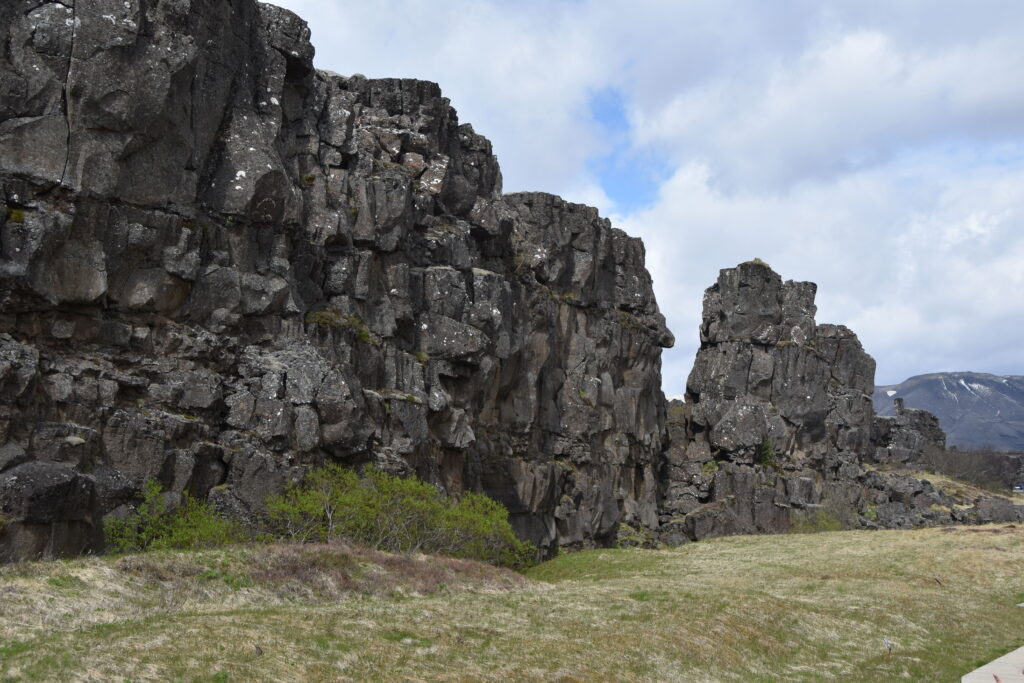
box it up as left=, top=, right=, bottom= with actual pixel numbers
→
left=634, top=30, right=1024, bottom=190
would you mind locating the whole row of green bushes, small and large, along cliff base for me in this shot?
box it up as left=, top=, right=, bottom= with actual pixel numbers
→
left=104, top=463, right=538, bottom=568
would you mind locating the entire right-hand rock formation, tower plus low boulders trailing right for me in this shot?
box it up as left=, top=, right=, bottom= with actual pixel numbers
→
left=658, top=261, right=1024, bottom=543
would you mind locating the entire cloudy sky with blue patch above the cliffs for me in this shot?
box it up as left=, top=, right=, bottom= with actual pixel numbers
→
left=275, top=0, right=1024, bottom=395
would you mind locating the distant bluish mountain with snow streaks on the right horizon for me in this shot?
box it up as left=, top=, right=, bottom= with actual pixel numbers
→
left=873, top=373, right=1024, bottom=451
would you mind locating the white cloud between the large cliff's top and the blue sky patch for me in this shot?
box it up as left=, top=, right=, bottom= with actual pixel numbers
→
left=268, top=0, right=614, bottom=202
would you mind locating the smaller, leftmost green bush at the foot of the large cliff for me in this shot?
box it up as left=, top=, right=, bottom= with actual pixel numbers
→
left=103, top=479, right=247, bottom=553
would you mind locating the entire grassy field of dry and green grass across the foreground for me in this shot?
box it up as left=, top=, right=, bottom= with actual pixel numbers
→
left=0, top=525, right=1024, bottom=681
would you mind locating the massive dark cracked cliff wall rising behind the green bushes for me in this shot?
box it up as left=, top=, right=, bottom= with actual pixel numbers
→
left=0, top=0, right=672, bottom=559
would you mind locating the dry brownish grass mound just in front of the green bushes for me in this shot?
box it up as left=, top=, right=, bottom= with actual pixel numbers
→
left=0, top=544, right=526, bottom=651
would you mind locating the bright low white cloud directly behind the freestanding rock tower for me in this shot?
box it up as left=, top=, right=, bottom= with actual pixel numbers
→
left=620, top=154, right=1024, bottom=391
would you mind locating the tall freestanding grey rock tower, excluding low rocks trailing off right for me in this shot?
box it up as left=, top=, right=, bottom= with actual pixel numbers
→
left=662, top=261, right=874, bottom=540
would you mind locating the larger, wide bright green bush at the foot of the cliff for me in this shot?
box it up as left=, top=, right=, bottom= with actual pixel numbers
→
left=267, top=464, right=537, bottom=567
